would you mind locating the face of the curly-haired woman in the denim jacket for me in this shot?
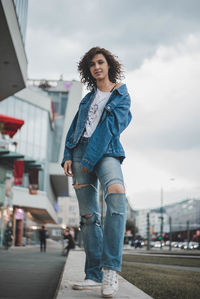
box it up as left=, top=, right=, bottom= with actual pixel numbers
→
left=89, top=54, right=109, bottom=81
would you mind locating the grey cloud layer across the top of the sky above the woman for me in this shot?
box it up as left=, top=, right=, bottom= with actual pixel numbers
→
left=26, top=0, right=200, bottom=78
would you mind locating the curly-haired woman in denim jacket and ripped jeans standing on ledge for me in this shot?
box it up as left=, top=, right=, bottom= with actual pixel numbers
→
left=61, top=47, right=131, bottom=297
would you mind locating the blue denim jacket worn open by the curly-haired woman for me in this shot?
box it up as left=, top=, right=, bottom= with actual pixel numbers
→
left=61, top=84, right=132, bottom=170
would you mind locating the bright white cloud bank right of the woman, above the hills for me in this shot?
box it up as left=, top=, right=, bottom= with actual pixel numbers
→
left=122, top=34, right=200, bottom=207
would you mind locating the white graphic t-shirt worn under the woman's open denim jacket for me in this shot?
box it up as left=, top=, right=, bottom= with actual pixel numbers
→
left=83, top=88, right=111, bottom=137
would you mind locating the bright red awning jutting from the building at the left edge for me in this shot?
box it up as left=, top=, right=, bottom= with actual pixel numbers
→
left=0, top=114, right=24, bottom=138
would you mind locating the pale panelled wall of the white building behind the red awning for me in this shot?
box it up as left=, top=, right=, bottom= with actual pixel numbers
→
left=0, top=88, right=56, bottom=219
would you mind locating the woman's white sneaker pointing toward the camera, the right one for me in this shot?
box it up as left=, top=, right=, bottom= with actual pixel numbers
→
left=101, top=269, right=119, bottom=298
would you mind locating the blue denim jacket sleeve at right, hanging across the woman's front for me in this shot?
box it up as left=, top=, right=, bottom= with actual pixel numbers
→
left=81, top=95, right=132, bottom=170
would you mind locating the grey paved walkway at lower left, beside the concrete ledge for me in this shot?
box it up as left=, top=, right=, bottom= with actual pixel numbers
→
left=0, top=240, right=65, bottom=299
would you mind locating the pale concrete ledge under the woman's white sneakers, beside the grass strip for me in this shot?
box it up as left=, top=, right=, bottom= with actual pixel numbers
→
left=56, top=250, right=152, bottom=299
